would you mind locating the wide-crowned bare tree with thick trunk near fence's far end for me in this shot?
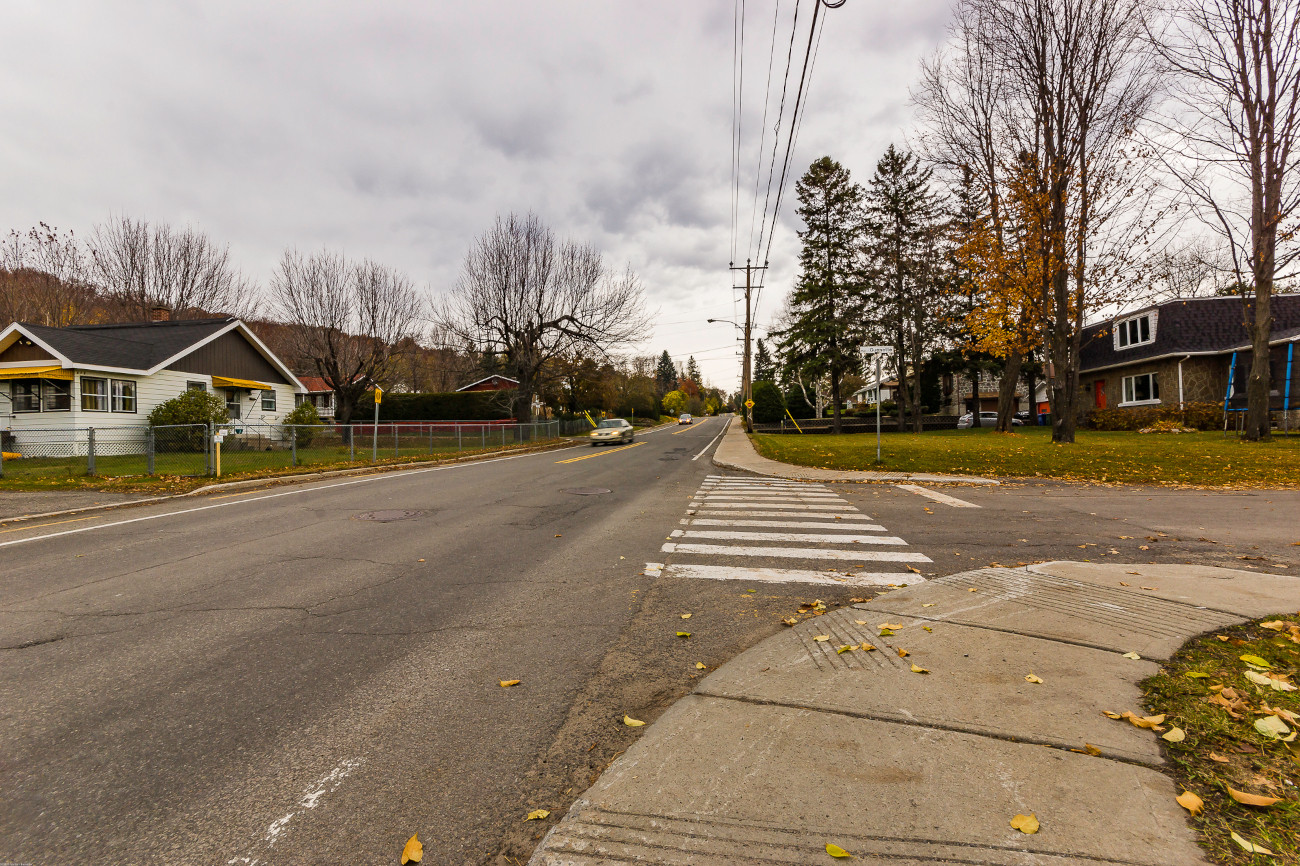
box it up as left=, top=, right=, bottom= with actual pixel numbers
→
left=433, top=213, right=646, bottom=421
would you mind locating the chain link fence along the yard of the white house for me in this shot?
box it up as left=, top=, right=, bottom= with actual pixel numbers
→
left=0, top=421, right=562, bottom=479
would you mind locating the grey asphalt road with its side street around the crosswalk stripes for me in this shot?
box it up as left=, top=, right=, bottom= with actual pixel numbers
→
left=0, top=420, right=1300, bottom=866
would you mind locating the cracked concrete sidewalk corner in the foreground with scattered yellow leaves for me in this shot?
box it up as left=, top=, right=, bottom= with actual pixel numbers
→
left=530, top=562, right=1300, bottom=866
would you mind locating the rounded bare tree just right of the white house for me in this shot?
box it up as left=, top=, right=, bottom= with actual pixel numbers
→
left=270, top=250, right=423, bottom=424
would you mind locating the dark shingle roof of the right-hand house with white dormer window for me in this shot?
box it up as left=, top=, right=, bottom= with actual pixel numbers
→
left=1080, top=294, right=1300, bottom=371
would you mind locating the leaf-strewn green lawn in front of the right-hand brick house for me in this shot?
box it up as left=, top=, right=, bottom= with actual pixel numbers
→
left=753, top=426, right=1300, bottom=486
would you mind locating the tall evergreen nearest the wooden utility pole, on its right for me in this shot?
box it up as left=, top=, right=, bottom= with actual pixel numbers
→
left=775, top=156, right=865, bottom=433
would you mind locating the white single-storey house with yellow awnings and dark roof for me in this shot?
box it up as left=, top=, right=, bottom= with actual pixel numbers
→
left=0, top=311, right=306, bottom=434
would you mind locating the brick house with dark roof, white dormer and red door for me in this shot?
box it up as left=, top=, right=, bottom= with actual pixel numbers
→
left=1079, top=294, right=1300, bottom=426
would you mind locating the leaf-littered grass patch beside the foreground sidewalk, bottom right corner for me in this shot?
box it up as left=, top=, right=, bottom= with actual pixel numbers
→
left=1141, top=614, right=1300, bottom=866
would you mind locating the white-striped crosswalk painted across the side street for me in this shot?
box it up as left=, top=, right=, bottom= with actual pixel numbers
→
left=646, top=475, right=931, bottom=586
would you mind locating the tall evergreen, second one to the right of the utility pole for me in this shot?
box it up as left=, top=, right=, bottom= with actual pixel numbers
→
left=865, top=144, right=948, bottom=433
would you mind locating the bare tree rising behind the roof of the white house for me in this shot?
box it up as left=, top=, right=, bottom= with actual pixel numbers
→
left=88, top=216, right=256, bottom=320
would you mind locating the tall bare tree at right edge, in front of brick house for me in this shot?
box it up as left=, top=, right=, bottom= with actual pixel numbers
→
left=1153, top=0, right=1300, bottom=440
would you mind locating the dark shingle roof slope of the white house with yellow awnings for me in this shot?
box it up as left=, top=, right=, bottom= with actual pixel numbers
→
left=22, top=317, right=234, bottom=369
